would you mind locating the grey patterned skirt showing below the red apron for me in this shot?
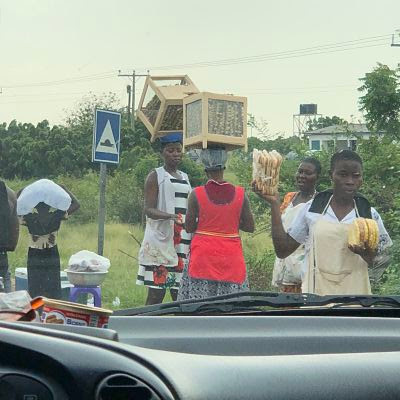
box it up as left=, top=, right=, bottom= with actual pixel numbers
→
left=178, top=264, right=250, bottom=300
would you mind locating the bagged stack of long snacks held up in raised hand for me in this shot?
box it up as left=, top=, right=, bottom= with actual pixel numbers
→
left=253, top=149, right=283, bottom=196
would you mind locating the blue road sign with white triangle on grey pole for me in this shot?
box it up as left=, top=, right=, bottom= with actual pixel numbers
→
left=92, top=110, right=121, bottom=256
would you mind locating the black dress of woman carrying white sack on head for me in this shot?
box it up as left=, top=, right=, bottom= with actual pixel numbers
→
left=23, top=210, right=66, bottom=299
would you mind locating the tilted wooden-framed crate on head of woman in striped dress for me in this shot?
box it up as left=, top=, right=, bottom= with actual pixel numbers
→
left=137, top=75, right=199, bottom=142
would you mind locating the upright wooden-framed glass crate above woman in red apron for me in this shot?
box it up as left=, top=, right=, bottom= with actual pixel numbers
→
left=183, top=92, right=247, bottom=151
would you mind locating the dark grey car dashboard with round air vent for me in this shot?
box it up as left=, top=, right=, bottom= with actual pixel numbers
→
left=0, top=316, right=400, bottom=400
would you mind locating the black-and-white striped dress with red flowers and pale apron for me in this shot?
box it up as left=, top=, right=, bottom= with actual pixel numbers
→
left=136, top=168, right=191, bottom=290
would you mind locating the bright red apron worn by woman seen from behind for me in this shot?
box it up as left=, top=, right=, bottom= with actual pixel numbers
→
left=189, top=186, right=246, bottom=284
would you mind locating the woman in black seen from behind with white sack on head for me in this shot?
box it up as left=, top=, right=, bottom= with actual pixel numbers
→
left=17, top=179, right=79, bottom=299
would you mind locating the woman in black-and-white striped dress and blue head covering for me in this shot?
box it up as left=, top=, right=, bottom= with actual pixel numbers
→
left=136, top=133, right=192, bottom=305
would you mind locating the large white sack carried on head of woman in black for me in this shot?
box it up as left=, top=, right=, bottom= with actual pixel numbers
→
left=17, top=179, right=72, bottom=215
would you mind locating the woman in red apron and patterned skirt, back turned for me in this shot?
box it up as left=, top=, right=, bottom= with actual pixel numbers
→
left=178, top=150, right=254, bottom=300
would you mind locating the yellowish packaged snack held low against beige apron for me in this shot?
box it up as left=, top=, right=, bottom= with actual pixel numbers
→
left=348, top=218, right=379, bottom=251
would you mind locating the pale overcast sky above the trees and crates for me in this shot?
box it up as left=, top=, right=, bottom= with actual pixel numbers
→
left=0, top=0, right=400, bottom=136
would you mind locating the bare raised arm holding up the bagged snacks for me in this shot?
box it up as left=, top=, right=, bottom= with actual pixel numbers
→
left=253, top=185, right=300, bottom=258
